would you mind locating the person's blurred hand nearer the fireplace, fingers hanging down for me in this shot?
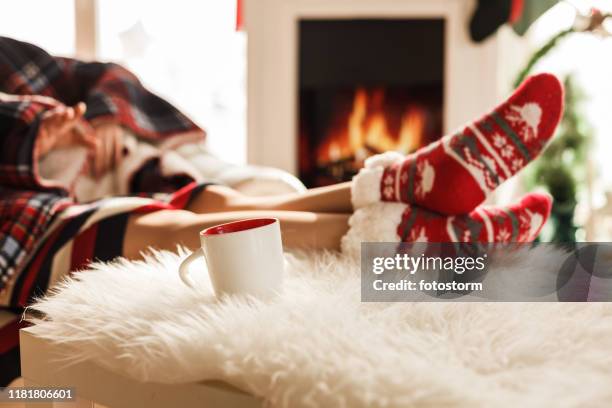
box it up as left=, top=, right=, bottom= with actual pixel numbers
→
left=90, top=122, right=123, bottom=178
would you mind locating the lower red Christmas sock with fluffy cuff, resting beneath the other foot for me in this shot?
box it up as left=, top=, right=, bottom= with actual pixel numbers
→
left=342, top=193, right=552, bottom=252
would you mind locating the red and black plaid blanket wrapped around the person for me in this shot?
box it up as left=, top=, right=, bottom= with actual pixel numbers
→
left=0, top=37, right=204, bottom=385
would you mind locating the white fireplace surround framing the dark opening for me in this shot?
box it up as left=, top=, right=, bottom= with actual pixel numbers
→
left=244, top=0, right=521, bottom=174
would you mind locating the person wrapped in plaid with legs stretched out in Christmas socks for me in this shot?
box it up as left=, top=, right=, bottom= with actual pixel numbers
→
left=0, top=38, right=563, bottom=386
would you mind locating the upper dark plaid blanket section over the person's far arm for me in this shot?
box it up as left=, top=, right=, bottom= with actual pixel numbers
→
left=0, top=37, right=204, bottom=142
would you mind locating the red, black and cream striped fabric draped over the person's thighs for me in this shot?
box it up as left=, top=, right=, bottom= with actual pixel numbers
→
left=0, top=183, right=206, bottom=386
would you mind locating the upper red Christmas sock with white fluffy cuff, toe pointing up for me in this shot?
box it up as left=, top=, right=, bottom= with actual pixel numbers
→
left=352, top=74, right=563, bottom=214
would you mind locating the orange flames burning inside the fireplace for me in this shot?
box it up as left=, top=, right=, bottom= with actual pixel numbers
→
left=317, top=88, right=426, bottom=165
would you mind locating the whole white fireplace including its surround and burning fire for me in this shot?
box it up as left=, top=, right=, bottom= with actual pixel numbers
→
left=244, top=0, right=522, bottom=182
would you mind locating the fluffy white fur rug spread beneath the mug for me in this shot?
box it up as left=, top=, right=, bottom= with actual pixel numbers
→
left=27, top=247, right=612, bottom=407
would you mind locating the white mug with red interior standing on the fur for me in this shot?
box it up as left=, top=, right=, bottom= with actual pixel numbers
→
left=179, top=218, right=284, bottom=297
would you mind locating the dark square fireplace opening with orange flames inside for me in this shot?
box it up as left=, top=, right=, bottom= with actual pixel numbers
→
left=298, top=19, right=444, bottom=187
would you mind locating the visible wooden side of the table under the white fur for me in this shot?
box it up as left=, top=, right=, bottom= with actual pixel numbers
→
left=20, top=329, right=263, bottom=408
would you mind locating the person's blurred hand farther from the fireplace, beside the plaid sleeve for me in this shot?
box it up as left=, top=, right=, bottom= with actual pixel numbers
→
left=35, top=102, right=98, bottom=157
